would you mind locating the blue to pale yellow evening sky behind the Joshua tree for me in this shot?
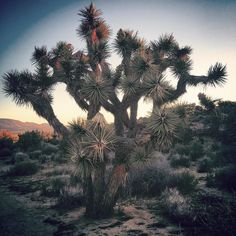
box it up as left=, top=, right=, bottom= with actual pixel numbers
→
left=0, top=0, right=236, bottom=124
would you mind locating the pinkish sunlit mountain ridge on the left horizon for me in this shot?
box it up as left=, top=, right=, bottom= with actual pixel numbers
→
left=0, top=118, right=53, bottom=133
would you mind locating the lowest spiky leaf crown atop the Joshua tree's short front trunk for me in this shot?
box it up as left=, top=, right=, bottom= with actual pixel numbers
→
left=68, top=119, right=116, bottom=165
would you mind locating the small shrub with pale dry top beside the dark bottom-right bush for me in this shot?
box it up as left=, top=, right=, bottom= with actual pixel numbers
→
left=159, top=188, right=190, bottom=223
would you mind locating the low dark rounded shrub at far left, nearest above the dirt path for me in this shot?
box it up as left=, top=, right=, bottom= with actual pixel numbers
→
left=7, top=161, right=39, bottom=176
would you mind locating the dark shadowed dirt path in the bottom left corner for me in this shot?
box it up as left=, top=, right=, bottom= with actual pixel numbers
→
left=0, top=188, right=54, bottom=236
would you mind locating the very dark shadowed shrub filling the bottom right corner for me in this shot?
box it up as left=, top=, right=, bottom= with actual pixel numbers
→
left=189, top=192, right=236, bottom=236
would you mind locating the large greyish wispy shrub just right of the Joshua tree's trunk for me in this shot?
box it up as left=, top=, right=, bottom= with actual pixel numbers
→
left=126, top=155, right=172, bottom=196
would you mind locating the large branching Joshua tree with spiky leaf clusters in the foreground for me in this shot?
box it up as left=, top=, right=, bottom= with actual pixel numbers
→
left=3, top=4, right=226, bottom=217
